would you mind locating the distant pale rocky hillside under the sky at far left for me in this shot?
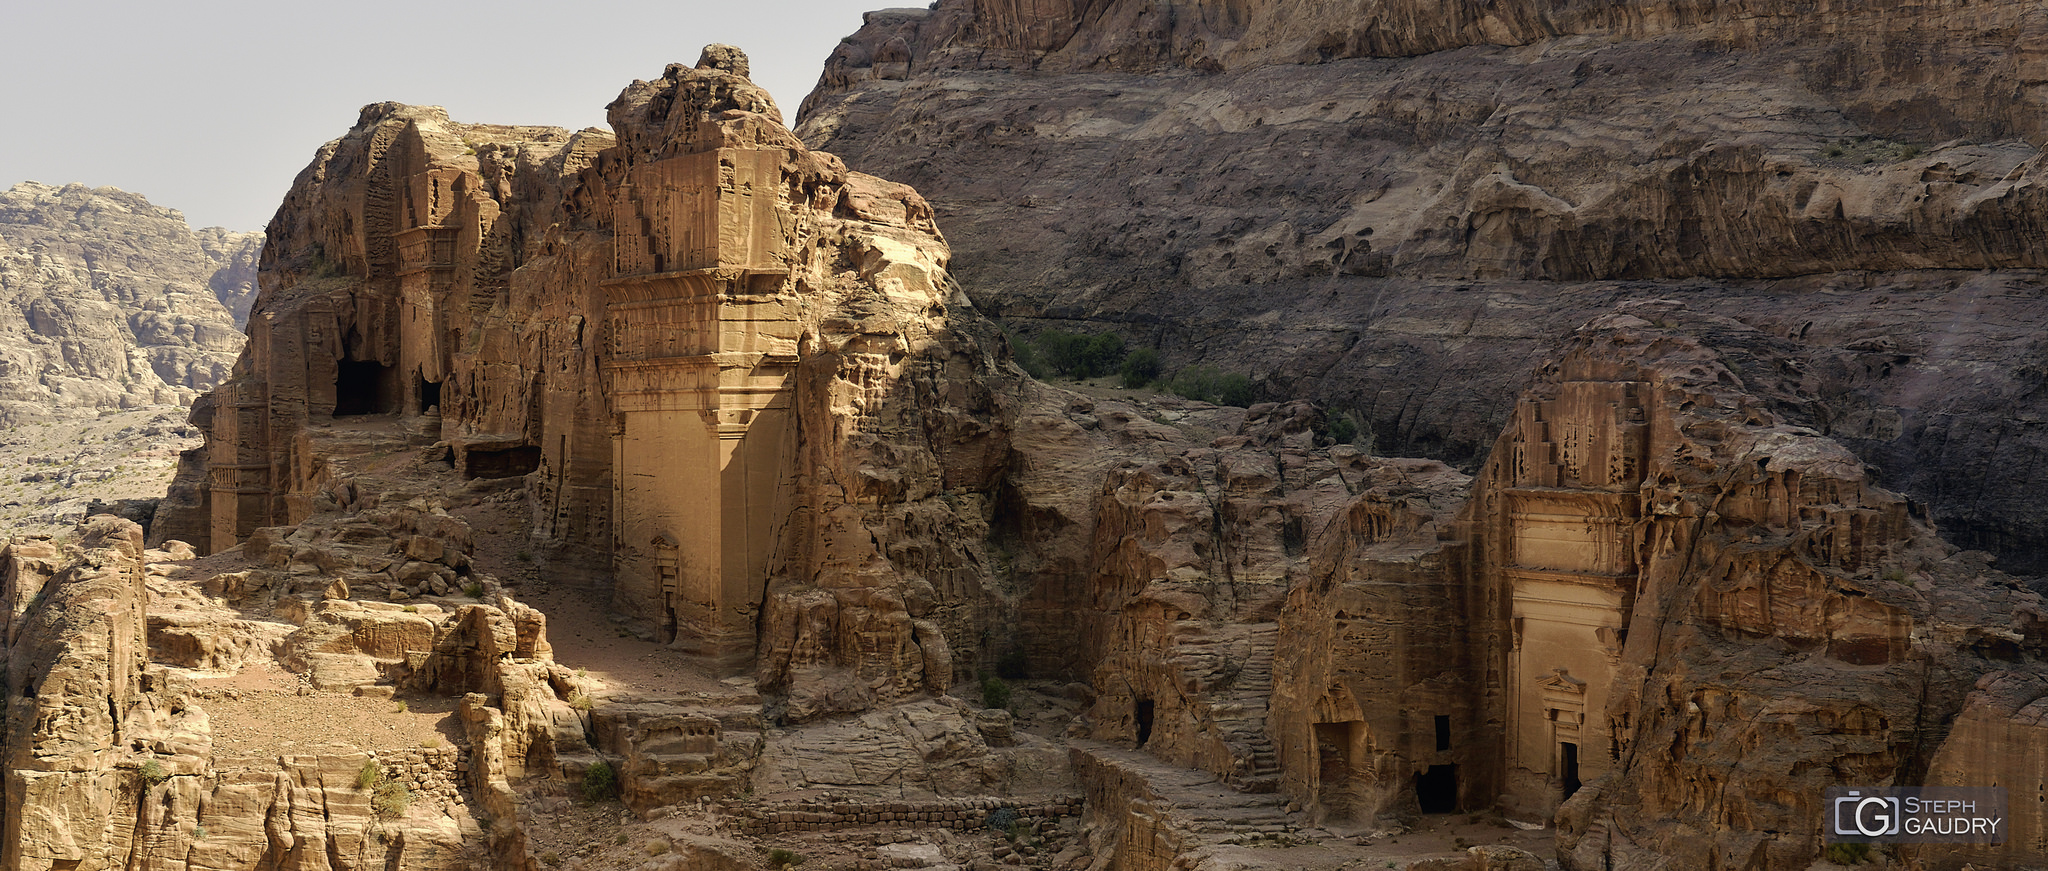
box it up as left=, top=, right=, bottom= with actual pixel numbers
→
left=0, top=182, right=262, bottom=531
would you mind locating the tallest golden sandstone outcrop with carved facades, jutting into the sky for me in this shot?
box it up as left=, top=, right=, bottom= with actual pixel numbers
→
left=164, top=47, right=1016, bottom=733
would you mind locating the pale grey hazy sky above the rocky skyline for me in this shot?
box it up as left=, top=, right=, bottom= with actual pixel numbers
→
left=0, top=0, right=903, bottom=230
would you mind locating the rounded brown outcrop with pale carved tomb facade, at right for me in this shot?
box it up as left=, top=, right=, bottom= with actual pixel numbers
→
left=1490, top=309, right=2048, bottom=867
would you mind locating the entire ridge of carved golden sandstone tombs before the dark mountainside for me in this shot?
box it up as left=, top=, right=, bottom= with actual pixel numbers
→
left=96, top=30, right=2048, bottom=867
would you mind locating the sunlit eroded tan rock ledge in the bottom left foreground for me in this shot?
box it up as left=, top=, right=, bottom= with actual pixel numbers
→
left=0, top=516, right=495, bottom=871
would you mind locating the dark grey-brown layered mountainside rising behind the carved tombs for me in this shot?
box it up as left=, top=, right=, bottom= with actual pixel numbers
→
left=797, top=0, right=2048, bottom=572
